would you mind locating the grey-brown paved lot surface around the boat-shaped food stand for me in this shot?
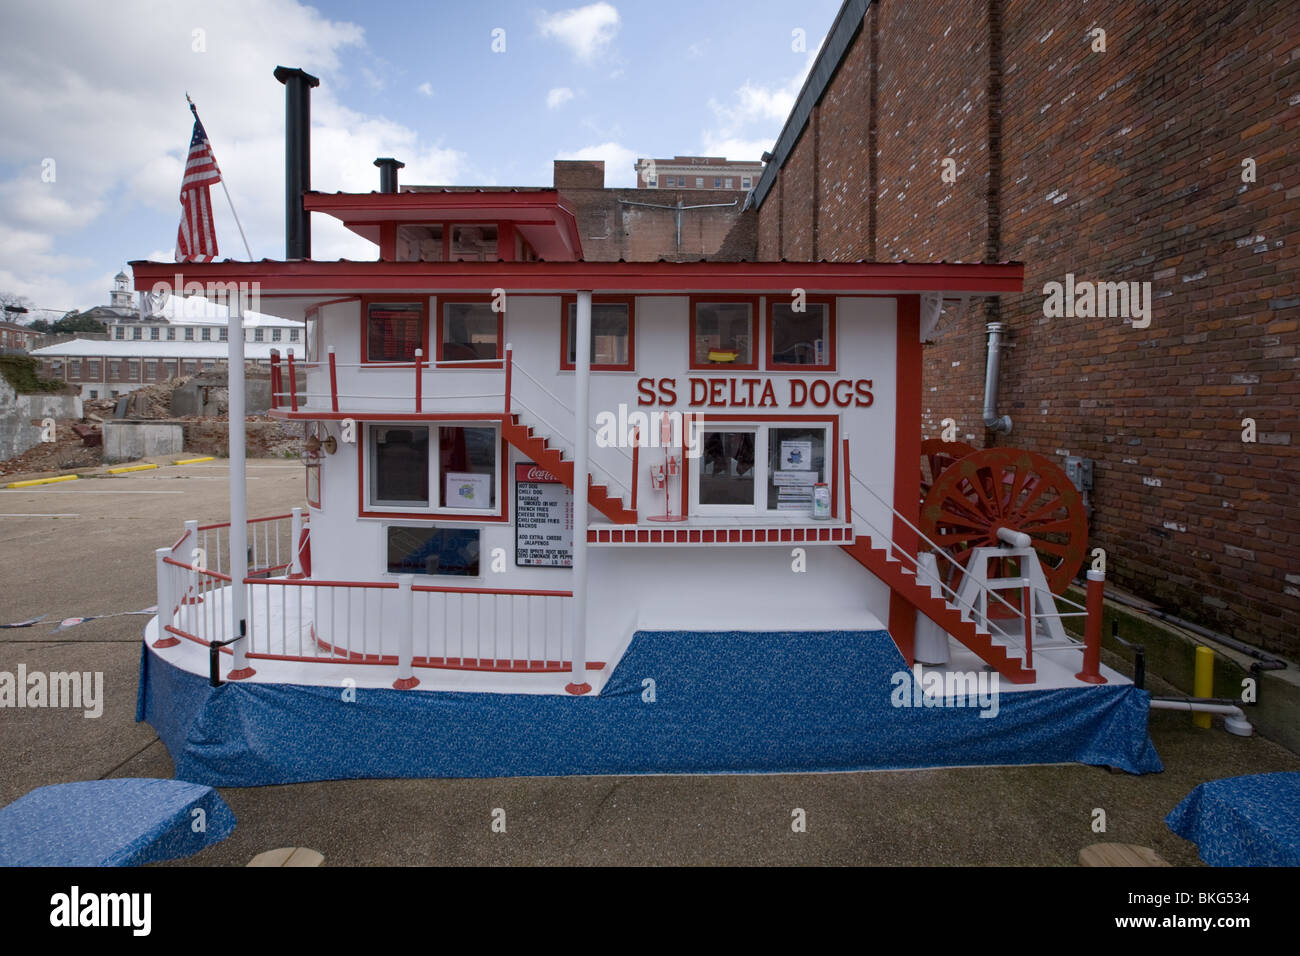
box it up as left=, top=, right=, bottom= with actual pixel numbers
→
left=0, top=460, right=1300, bottom=865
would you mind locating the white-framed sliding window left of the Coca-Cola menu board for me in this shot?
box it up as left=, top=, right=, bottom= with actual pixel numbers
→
left=361, top=423, right=504, bottom=519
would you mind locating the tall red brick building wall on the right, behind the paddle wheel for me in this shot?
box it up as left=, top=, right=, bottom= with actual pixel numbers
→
left=743, top=0, right=1300, bottom=654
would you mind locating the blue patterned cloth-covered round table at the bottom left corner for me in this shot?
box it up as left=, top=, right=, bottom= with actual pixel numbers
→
left=0, top=778, right=235, bottom=866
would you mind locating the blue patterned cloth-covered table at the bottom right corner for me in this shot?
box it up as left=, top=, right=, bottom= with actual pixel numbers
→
left=1165, top=774, right=1300, bottom=866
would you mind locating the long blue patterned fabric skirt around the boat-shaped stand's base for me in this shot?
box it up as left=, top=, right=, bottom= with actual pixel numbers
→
left=137, top=631, right=1161, bottom=787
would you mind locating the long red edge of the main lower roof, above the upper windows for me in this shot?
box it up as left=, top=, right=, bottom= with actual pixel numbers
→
left=131, top=259, right=1024, bottom=295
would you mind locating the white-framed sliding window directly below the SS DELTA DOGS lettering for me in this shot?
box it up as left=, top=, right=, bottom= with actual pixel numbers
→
left=692, top=421, right=835, bottom=518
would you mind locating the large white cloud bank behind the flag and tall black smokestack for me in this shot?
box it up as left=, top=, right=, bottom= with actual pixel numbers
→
left=0, top=0, right=465, bottom=308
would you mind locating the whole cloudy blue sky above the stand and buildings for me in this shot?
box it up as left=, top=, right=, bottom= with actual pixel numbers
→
left=0, top=0, right=840, bottom=321
